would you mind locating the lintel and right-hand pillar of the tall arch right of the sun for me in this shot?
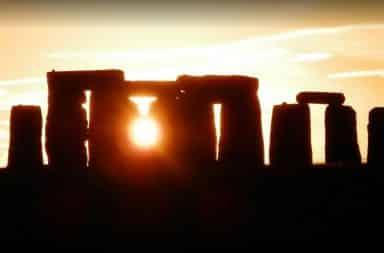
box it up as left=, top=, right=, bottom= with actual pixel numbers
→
left=177, top=75, right=264, bottom=170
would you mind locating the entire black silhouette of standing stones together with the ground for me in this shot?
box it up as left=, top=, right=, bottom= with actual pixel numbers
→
left=0, top=70, right=378, bottom=243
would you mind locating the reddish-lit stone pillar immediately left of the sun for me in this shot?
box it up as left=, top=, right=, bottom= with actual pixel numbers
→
left=89, top=83, right=136, bottom=172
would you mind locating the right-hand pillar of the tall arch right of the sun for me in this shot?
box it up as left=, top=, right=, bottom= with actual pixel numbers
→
left=219, top=79, right=264, bottom=168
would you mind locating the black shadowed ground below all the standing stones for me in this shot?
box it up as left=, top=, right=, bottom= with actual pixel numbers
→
left=0, top=165, right=384, bottom=247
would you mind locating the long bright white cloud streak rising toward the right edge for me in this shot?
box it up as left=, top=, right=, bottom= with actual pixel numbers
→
left=47, top=23, right=384, bottom=67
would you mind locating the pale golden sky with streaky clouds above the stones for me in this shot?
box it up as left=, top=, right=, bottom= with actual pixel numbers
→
left=0, top=0, right=384, bottom=166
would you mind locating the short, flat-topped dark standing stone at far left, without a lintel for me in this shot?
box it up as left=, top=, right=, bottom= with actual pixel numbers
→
left=8, top=105, right=43, bottom=171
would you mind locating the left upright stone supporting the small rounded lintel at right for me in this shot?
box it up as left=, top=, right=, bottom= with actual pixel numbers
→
left=269, top=103, right=312, bottom=172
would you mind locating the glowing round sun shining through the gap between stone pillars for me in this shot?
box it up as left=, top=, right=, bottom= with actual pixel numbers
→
left=130, top=117, right=159, bottom=148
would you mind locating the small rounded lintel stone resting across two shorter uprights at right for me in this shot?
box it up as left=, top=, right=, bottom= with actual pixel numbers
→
left=296, top=91, right=345, bottom=105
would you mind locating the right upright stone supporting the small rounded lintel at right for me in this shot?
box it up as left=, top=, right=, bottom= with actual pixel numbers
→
left=325, top=105, right=361, bottom=165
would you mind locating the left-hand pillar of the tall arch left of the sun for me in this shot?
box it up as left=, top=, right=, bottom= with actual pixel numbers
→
left=46, top=86, right=87, bottom=170
